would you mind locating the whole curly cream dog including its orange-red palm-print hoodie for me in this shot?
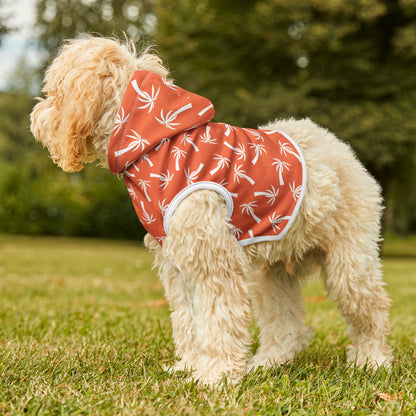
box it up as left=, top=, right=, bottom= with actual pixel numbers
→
left=31, top=37, right=392, bottom=384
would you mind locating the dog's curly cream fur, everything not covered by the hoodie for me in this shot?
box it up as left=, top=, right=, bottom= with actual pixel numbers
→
left=31, top=37, right=392, bottom=384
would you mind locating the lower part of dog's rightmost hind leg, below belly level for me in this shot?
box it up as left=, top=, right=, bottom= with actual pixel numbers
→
left=323, top=242, right=392, bottom=368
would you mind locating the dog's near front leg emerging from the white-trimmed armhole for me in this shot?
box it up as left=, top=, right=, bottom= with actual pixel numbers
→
left=163, top=191, right=251, bottom=385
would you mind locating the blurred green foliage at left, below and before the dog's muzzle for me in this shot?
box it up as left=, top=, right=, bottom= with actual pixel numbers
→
left=0, top=92, right=144, bottom=238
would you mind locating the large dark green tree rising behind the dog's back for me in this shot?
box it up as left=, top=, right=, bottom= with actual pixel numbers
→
left=156, top=0, right=416, bottom=231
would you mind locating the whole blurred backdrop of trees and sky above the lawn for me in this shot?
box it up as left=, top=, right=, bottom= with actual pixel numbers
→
left=0, top=0, right=416, bottom=238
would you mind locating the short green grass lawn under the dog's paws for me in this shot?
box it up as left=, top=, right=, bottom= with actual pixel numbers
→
left=0, top=235, right=416, bottom=415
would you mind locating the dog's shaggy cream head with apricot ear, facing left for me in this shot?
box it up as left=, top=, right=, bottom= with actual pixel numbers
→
left=31, top=37, right=135, bottom=172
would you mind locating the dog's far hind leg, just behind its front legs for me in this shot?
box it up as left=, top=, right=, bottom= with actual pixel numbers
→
left=250, top=263, right=313, bottom=369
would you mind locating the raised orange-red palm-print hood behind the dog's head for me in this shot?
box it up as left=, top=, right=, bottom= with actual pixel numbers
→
left=108, top=71, right=214, bottom=174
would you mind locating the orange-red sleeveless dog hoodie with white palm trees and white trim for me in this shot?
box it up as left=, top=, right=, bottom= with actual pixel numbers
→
left=108, top=71, right=306, bottom=246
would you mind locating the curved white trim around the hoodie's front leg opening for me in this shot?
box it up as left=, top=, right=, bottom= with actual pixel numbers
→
left=163, top=181, right=234, bottom=235
